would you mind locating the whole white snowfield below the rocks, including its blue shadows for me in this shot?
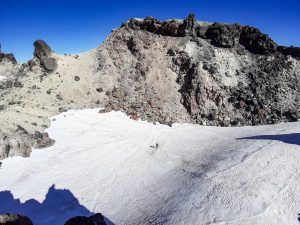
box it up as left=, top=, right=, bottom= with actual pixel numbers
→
left=0, top=109, right=300, bottom=225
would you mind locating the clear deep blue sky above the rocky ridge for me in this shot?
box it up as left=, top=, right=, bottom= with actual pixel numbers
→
left=0, top=0, right=300, bottom=62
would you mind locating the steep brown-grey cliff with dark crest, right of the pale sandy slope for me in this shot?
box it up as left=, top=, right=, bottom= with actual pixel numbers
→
left=100, top=15, right=300, bottom=126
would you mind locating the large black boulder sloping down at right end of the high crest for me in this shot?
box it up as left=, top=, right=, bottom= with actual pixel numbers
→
left=240, top=26, right=277, bottom=54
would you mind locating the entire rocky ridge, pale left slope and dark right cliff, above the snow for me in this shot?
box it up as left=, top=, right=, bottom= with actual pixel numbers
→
left=0, top=14, right=300, bottom=159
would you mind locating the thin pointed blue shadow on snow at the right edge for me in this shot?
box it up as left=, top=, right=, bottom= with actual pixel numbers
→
left=237, top=133, right=300, bottom=145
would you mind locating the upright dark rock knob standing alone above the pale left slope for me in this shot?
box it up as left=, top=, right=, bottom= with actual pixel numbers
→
left=33, top=40, right=57, bottom=71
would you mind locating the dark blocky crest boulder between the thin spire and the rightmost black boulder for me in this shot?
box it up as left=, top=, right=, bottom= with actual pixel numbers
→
left=205, top=23, right=242, bottom=48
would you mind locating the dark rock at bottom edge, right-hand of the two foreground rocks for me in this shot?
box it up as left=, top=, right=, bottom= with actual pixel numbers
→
left=65, top=213, right=106, bottom=225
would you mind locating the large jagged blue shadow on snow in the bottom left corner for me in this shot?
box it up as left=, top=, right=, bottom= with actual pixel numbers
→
left=0, top=185, right=113, bottom=225
